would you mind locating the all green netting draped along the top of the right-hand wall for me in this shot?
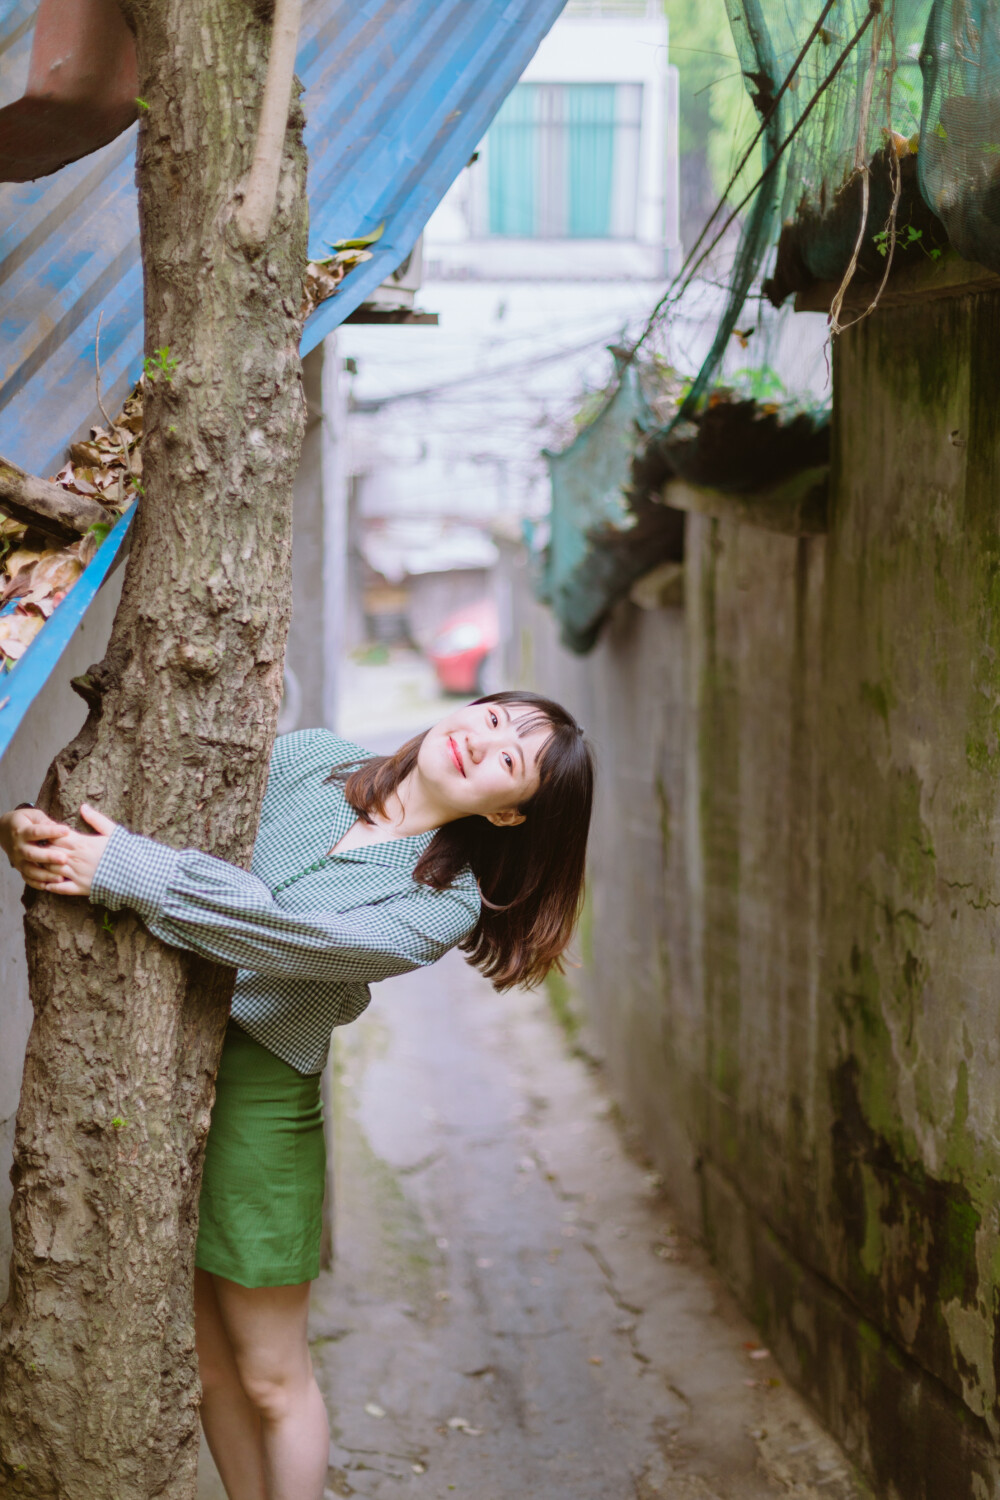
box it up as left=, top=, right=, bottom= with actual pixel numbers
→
left=530, top=0, right=1000, bottom=651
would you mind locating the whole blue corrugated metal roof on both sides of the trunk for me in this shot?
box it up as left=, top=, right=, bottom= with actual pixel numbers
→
left=0, top=0, right=564, bottom=755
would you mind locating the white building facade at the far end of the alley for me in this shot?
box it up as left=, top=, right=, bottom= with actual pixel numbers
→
left=337, top=0, right=681, bottom=663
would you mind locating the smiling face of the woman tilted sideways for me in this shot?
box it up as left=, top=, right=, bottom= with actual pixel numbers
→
left=417, top=704, right=552, bottom=827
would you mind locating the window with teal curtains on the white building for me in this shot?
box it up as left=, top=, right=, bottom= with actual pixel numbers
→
left=487, top=84, right=642, bottom=240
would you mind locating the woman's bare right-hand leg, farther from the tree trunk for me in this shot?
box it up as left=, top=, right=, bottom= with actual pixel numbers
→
left=211, top=1277, right=330, bottom=1500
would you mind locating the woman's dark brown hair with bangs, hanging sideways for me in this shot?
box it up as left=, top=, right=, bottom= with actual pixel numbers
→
left=331, top=690, right=594, bottom=990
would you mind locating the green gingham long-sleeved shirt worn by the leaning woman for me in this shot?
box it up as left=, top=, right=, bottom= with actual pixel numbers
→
left=90, top=729, right=480, bottom=1074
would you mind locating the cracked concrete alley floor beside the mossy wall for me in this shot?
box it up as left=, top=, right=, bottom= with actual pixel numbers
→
left=199, top=954, right=870, bottom=1500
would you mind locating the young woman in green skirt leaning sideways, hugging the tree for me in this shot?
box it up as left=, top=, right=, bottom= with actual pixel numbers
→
left=0, top=693, right=594, bottom=1500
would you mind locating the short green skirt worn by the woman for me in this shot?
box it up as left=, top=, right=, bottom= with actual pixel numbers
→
left=195, top=1022, right=327, bottom=1287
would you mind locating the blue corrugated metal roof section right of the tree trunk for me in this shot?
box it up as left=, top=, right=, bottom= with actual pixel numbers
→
left=296, top=0, right=564, bottom=348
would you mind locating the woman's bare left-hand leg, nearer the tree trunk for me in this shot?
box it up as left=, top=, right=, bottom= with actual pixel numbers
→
left=195, top=1271, right=268, bottom=1500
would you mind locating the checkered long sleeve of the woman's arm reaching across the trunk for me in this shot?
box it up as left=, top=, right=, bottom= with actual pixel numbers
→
left=90, top=828, right=478, bottom=984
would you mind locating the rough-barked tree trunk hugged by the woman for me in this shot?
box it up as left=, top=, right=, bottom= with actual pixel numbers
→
left=0, top=0, right=307, bottom=1500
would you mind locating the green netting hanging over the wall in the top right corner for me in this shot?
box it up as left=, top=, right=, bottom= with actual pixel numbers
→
left=677, top=0, right=1000, bottom=416
